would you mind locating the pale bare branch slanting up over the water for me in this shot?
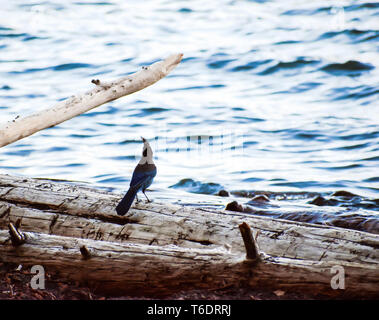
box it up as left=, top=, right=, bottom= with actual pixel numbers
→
left=0, top=53, right=183, bottom=147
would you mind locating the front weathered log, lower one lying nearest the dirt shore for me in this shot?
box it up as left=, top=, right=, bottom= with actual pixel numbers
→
left=0, top=230, right=379, bottom=298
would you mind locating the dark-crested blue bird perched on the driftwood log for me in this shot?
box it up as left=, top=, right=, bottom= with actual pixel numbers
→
left=116, top=137, right=157, bottom=216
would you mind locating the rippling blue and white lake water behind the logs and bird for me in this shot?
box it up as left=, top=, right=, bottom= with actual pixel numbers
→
left=0, top=0, right=379, bottom=230
